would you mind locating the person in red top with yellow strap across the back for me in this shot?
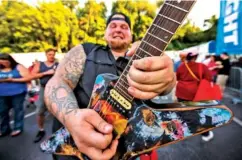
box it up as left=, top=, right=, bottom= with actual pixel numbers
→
left=176, top=52, right=214, bottom=141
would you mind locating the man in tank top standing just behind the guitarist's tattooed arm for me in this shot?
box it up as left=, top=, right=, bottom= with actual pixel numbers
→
left=31, top=49, right=58, bottom=143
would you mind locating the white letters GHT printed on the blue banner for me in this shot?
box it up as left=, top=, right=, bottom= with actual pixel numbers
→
left=224, top=0, right=239, bottom=45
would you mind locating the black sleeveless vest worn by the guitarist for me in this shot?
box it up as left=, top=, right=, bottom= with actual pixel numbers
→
left=52, top=43, right=125, bottom=132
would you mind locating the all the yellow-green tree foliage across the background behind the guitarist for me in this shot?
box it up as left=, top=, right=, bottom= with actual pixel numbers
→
left=0, top=0, right=218, bottom=53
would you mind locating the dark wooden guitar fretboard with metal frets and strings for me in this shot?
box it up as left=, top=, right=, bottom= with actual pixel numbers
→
left=114, top=0, right=196, bottom=102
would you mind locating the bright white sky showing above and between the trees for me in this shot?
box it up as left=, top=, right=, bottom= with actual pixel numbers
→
left=23, top=0, right=220, bottom=29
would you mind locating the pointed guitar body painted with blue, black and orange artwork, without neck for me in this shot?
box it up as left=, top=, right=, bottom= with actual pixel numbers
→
left=41, top=74, right=233, bottom=159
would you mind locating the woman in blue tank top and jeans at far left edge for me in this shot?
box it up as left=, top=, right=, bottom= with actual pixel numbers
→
left=0, top=54, right=54, bottom=137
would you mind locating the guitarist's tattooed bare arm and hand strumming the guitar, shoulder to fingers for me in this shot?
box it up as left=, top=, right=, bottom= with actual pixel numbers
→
left=45, top=45, right=118, bottom=159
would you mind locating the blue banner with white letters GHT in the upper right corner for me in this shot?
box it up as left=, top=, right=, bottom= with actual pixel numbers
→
left=216, top=0, right=242, bottom=54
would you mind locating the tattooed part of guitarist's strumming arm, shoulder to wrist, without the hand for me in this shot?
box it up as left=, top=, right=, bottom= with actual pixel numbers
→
left=45, top=45, right=86, bottom=124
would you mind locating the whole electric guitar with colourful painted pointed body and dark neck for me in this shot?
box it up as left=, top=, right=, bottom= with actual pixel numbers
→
left=41, top=0, right=233, bottom=160
